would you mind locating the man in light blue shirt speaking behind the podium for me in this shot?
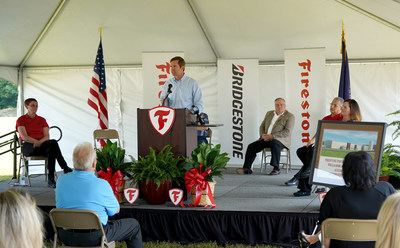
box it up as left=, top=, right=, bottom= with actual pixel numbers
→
left=160, top=56, right=204, bottom=113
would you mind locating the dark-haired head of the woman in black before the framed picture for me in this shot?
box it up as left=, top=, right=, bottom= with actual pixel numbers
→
left=342, top=151, right=376, bottom=190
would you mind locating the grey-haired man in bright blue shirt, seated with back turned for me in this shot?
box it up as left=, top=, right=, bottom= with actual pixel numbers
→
left=55, top=142, right=143, bottom=248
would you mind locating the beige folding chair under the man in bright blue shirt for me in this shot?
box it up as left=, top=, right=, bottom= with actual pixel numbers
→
left=49, top=208, right=115, bottom=248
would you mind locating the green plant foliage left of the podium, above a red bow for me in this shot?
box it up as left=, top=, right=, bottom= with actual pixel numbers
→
left=96, top=140, right=132, bottom=176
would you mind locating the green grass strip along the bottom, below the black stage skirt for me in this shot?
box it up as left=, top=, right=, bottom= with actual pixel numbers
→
left=45, top=242, right=282, bottom=248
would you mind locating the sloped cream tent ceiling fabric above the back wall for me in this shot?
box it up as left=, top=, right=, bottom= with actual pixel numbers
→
left=0, top=0, right=400, bottom=67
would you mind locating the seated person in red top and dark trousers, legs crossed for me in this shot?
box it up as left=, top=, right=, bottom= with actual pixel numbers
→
left=16, top=98, right=72, bottom=188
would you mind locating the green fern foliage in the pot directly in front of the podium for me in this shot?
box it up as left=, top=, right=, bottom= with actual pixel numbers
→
left=129, top=145, right=185, bottom=188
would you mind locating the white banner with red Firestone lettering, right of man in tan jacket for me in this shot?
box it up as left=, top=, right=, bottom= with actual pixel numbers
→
left=285, top=48, right=324, bottom=154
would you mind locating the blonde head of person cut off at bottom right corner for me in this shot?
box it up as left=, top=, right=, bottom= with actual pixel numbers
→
left=375, top=193, right=400, bottom=248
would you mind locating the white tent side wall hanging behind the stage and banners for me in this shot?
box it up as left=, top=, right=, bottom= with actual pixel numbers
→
left=18, top=63, right=400, bottom=170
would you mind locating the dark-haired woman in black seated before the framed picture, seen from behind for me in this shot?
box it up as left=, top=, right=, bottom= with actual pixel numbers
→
left=299, top=151, right=396, bottom=248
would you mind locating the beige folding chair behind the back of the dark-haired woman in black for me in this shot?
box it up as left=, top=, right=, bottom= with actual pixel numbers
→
left=321, top=218, right=378, bottom=248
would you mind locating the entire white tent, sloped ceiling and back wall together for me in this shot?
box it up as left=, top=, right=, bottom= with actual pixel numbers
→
left=0, top=0, right=400, bottom=168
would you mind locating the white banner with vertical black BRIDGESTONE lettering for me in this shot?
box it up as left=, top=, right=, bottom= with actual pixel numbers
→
left=217, top=59, right=260, bottom=164
